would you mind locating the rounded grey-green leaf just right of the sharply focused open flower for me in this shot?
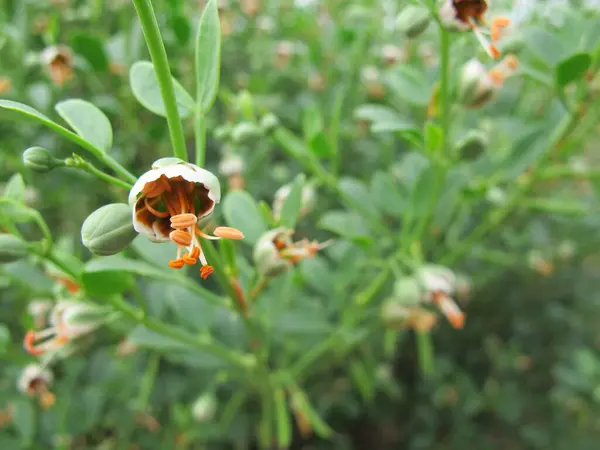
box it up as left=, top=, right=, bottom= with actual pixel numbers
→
left=223, top=191, right=267, bottom=244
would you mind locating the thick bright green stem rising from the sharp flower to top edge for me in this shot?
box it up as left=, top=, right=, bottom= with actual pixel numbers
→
left=133, top=0, right=187, bottom=161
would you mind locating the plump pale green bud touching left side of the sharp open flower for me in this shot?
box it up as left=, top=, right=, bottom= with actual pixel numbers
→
left=81, top=203, right=137, bottom=256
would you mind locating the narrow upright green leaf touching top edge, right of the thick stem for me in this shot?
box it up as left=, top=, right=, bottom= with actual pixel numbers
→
left=196, top=0, right=221, bottom=114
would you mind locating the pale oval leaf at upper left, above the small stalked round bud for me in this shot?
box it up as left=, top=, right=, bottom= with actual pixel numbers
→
left=54, top=99, right=112, bottom=152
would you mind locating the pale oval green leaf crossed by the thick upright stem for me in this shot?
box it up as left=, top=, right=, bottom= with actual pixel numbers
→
left=129, top=61, right=194, bottom=118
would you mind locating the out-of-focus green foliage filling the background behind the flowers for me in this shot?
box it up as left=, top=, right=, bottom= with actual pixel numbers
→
left=0, top=0, right=600, bottom=450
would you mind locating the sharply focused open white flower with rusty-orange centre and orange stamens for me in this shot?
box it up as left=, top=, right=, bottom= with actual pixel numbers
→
left=129, top=158, right=244, bottom=278
